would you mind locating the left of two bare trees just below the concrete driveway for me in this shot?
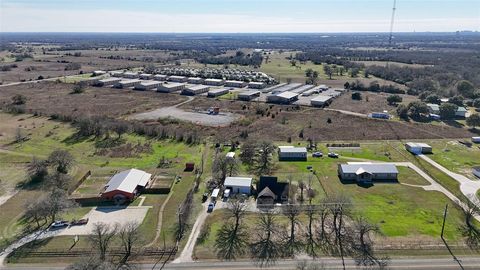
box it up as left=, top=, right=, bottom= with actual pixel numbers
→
left=88, top=222, right=117, bottom=261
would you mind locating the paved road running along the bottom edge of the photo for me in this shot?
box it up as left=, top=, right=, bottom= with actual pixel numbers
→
left=3, top=257, right=480, bottom=270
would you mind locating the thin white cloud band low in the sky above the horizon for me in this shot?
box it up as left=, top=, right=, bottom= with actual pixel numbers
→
left=0, top=4, right=480, bottom=33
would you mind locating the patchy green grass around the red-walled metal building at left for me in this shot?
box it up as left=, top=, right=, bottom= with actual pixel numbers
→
left=0, top=113, right=203, bottom=261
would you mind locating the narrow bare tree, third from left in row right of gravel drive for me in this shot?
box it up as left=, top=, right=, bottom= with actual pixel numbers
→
left=282, top=204, right=302, bottom=256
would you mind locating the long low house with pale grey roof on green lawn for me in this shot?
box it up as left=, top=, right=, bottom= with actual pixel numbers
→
left=338, top=162, right=398, bottom=184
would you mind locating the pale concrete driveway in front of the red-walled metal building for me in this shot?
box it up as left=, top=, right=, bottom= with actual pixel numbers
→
left=58, top=206, right=151, bottom=235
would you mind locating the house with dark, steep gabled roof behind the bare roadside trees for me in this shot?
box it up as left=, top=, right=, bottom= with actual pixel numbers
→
left=257, top=176, right=289, bottom=206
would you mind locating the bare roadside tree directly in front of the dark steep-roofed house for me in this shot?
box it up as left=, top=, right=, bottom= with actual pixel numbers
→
left=250, top=212, right=282, bottom=267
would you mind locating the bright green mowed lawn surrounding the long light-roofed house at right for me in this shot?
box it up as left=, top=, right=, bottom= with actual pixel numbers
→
left=195, top=142, right=470, bottom=259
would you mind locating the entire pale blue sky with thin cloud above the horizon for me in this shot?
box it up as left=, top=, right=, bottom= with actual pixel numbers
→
left=0, top=0, right=480, bottom=33
